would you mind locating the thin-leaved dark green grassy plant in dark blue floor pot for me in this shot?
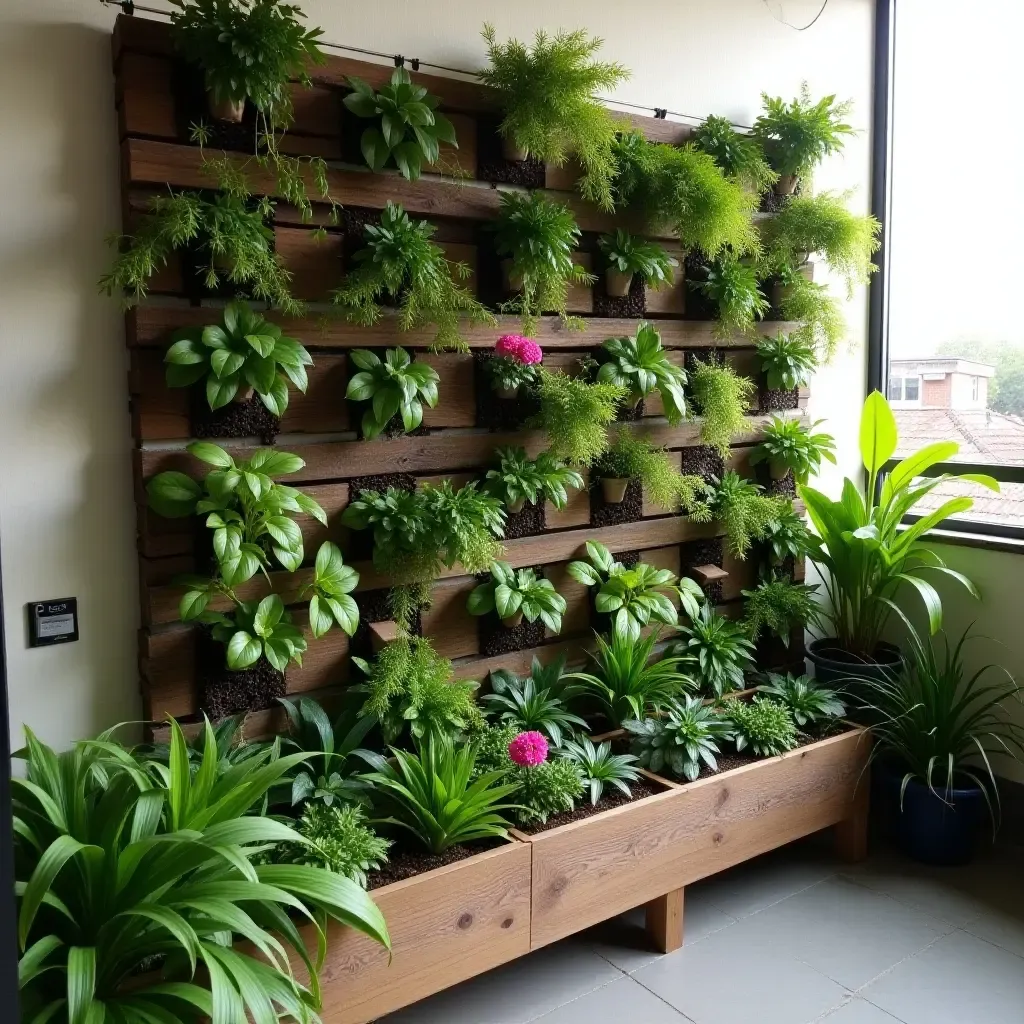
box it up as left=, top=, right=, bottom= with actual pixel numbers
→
left=861, top=629, right=1024, bottom=864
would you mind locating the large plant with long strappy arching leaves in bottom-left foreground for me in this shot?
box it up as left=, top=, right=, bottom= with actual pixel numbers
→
left=11, top=720, right=390, bottom=1024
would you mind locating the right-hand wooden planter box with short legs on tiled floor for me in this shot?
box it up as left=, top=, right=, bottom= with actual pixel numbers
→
left=517, top=728, right=869, bottom=952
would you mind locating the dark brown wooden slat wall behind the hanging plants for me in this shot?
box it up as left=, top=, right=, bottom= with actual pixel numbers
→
left=113, top=16, right=807, bottom=734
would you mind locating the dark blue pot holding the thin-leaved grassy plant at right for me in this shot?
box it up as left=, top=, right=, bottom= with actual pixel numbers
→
left=874, top=765, right=988, bottom=866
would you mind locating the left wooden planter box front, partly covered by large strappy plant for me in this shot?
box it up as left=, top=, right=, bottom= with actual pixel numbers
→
left=311, top=842, right=531, bottom=1024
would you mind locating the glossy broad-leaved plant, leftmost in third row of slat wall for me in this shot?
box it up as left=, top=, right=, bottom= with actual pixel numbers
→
left=164, top=301, right=313, bottom=417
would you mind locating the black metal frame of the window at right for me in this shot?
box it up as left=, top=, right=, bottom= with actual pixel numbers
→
left=867, top=0, right=1024, bottom=543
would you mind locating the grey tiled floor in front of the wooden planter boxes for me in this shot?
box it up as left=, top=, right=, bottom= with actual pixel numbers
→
left=379, top=841, right=1024, bottom=1024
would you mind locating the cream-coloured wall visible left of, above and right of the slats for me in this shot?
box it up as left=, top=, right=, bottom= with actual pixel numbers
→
left=0, top=0, right=873, bottom=745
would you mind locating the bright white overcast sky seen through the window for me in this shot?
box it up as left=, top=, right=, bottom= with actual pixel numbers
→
left=891, top=0, right=1024, bottom=356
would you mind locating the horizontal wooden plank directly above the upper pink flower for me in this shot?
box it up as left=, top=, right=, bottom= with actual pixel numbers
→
left=125, top=303, right=795, bottom=350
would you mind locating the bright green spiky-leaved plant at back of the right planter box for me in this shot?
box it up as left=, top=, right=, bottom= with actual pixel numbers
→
left=566, top=633, right=695, bottom=728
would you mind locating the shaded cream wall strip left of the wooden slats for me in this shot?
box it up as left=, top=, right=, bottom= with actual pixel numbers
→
left=0, top=16, right=139, bottom=746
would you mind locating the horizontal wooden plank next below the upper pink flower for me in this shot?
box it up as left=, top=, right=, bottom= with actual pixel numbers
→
left=134, top=414, right=796, bottom=485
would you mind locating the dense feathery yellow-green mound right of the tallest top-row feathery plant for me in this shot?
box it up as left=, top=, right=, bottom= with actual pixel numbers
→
left=615, top=132, right=759, bottom=259
